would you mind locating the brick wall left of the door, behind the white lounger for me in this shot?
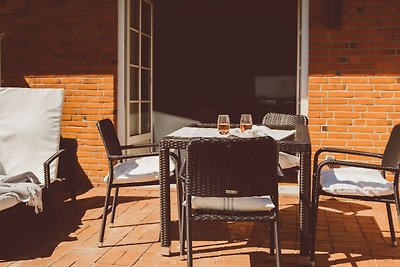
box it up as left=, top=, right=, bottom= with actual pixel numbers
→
left=0, top=0, right=118, bottom=183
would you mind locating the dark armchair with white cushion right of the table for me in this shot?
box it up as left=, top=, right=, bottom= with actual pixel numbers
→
left=310, top=124, right=400, bottom=266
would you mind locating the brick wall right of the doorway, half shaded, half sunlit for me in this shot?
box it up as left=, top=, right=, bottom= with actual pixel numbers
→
left=309, top=0, right=400, bottom=160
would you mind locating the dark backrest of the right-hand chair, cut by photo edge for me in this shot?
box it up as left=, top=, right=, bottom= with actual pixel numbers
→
left=382, top=124, right=400, bottom=168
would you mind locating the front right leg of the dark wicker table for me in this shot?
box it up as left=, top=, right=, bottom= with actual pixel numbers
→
left=299, top=149, right=311, bottom=256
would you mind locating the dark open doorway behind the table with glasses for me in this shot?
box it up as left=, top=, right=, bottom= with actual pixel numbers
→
left=153, top=0, right=297, bottom=123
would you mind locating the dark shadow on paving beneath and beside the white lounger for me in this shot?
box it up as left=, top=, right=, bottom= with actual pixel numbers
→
left=0, top=196, right=155, bottom=262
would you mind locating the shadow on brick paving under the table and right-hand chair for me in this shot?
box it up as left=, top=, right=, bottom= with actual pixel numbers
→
left=172, top=198, right=400, bottom=266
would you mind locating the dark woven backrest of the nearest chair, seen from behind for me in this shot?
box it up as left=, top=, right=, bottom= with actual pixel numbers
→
left=186, top=137, right=278, bottom=200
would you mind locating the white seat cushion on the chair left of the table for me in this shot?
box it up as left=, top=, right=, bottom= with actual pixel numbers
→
left=104, top=156, right=175, bottom=184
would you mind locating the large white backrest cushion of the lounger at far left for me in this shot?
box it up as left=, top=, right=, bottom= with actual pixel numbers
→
left=0, top=88, right=64, bottom=184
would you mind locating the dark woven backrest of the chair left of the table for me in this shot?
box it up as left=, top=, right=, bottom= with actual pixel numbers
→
left=97, top=119, right=122, bottom=157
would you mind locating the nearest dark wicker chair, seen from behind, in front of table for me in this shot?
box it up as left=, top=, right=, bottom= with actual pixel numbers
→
left=179, top=137, right=281, bottom=266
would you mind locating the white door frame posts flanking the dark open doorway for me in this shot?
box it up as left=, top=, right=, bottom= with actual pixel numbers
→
left=117, top=0, right=310, bottom=144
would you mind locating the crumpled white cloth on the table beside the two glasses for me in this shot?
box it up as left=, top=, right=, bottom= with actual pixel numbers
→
left=228, top=125, right=296, bottom=140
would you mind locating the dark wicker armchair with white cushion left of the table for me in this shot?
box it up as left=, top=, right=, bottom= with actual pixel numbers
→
left=97, top=119, right=179, bottom=247
